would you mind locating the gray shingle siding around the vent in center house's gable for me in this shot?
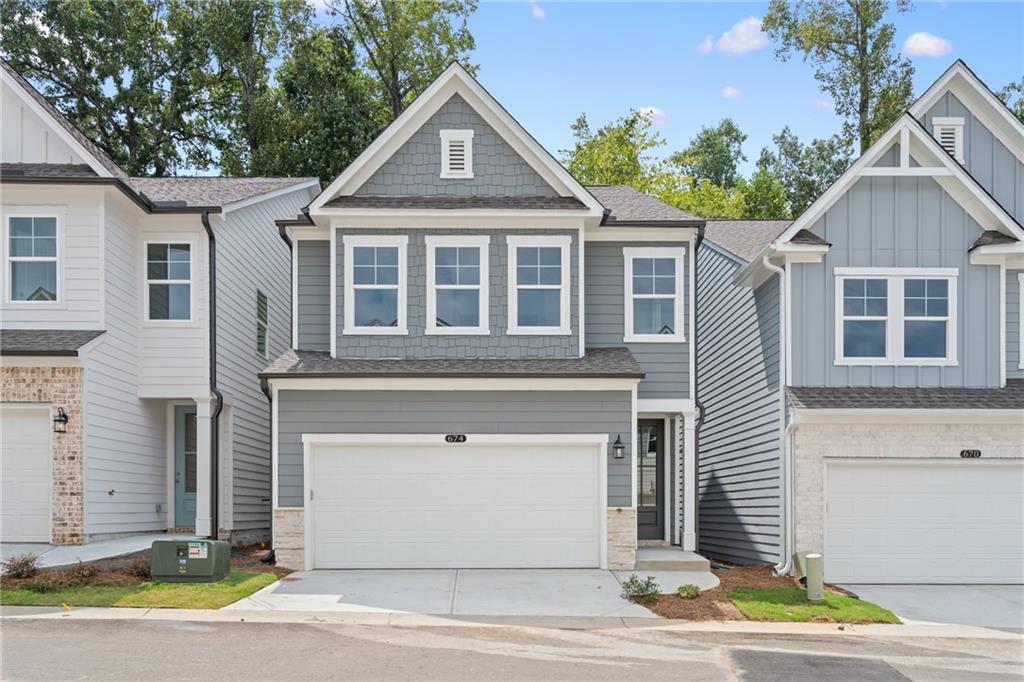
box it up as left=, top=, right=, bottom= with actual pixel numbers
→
left=355, top=95, right=557, bottom=197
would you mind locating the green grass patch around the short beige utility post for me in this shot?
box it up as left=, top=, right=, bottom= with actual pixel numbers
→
left=729, top=587, right=900, bottom=623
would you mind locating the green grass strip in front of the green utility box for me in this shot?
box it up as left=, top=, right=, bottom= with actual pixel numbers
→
left=0, top=571, right=278, bottom=608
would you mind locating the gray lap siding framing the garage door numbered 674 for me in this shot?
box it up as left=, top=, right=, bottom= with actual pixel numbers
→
left=278, top=390, right=633, bottom=507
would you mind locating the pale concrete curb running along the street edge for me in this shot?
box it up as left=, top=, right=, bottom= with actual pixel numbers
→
left=0, top=606, right=1024, bottom=641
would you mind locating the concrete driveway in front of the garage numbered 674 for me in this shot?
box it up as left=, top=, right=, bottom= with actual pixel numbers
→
left=226, top=568, right=718, bottom=617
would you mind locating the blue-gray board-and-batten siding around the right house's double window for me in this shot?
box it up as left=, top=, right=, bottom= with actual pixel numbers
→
left=792, top=177, right=999, bottom=387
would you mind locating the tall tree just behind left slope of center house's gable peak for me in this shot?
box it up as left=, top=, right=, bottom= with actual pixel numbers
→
left=335, top=0, right=476, bottom=120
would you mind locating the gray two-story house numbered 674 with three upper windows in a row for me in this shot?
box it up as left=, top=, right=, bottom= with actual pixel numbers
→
left=261, top=65, right=703, bottom=568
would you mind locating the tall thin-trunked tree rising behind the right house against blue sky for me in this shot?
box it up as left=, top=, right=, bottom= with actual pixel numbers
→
left=762, top=0, right=913, bottom=154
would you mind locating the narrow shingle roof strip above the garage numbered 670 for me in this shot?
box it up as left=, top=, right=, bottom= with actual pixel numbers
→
left=786, top=379, right=1024, bottom=409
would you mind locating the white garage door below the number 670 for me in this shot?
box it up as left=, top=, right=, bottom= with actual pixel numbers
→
left=824, top=460, right=1024, bottom=584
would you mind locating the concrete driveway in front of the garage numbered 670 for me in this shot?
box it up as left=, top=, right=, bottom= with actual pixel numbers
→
left=842, top=585, right=1024, bottom=630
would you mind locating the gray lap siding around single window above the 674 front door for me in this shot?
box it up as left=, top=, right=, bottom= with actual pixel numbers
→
left=584, top=242, right=692, bottom=398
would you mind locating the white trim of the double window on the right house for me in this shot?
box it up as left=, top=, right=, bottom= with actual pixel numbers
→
left=834, top=267, right=959, bottom=367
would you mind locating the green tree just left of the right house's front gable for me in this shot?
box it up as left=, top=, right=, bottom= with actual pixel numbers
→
left=758, top=126, right=852, bottom=216
